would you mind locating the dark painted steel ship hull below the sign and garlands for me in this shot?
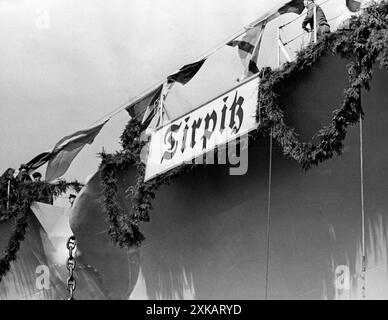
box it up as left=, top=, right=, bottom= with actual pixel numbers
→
left=0, top=56, right=388, bottom=299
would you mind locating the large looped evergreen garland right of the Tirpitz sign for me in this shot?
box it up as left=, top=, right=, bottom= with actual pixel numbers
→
left=256, top=4, right=388, bottom=169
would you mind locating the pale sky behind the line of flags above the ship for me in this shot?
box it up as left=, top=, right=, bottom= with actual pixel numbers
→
left=0, top=0, right=345, bottom=181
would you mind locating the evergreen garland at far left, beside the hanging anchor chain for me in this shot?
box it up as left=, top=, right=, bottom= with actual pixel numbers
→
left=0, top=179, right=82, bottom=282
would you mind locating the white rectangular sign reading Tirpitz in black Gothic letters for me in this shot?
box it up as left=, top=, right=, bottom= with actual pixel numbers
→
left=145, top=77, right=258, bottom=181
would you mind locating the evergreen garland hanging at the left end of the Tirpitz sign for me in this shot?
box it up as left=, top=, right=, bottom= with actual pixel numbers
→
left=100, top=119, right=192, bottom=248
